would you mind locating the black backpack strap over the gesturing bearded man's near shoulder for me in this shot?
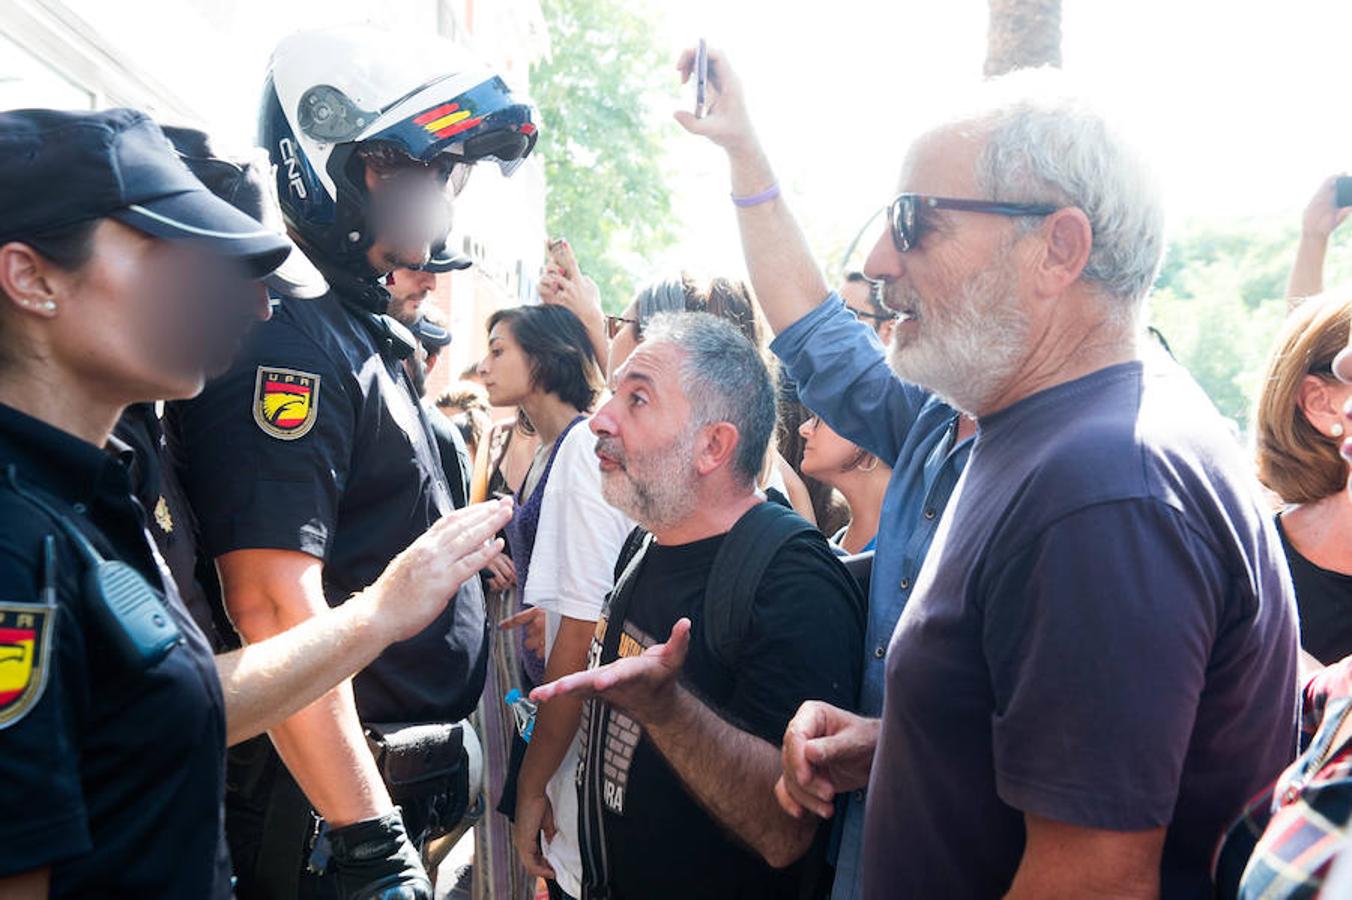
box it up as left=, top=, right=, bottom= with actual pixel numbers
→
left=704, top=501, right=819, bottom=669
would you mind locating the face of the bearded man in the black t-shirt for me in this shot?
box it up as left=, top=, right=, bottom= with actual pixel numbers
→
left=591, top=343, right=699, bottom=531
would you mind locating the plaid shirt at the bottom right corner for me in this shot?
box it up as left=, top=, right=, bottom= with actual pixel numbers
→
left=1215, top=657, right=1352, bottom=900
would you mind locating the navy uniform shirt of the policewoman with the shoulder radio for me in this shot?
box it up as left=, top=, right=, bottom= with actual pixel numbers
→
left=0, top=405, right=230, bottom=899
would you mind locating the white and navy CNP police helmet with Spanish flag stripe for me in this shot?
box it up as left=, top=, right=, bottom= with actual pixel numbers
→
left=258, top=27, right=538, bottom=276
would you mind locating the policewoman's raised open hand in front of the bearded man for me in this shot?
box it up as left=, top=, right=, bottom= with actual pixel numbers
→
left=359, top=500, right=512, bottom=643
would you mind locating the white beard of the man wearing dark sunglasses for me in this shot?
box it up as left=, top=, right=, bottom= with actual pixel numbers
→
left=887, top=257, right=1029, bottom=415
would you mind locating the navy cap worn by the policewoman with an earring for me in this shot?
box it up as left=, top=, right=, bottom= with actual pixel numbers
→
left=0, top=109, right=291, bottom=277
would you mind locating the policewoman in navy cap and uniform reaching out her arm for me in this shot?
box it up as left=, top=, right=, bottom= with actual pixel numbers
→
left=0, top=109, right=508, bottom=897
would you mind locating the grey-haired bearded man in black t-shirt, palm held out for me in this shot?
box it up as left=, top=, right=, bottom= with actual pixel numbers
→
left=533, top=314, right=864, bottom=900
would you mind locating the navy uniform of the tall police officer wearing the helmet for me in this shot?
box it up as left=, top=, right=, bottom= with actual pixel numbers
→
left=166, top=266, right=488, bottom=896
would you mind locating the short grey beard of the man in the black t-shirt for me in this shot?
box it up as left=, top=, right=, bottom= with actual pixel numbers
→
left=598, top=428, right=699, bottom=531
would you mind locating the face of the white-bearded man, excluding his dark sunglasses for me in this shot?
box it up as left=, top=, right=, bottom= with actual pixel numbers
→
left=865, top=132, right=1032, bottom=414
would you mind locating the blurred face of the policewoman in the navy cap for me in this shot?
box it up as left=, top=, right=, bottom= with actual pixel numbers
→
left=7, top=219, right=269, bottom=403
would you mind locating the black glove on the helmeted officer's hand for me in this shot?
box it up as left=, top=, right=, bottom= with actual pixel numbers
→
left=329, top=807, right=431, bottom=900
